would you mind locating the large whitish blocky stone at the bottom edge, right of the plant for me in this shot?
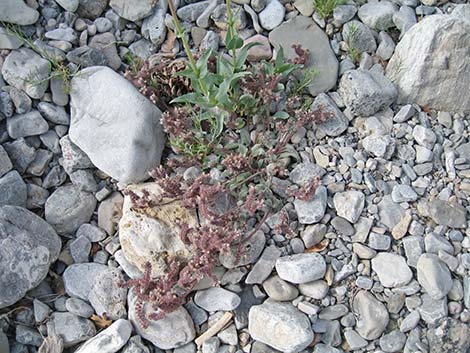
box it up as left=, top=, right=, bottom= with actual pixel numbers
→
left=248, top=301, right=313, bottom=353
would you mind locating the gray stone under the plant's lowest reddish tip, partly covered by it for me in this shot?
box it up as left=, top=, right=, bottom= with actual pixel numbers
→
left=127, top=291, right=196, bottom=349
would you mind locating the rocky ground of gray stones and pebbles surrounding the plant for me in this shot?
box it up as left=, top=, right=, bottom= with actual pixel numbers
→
left=0, top=0, right=470, bottom=353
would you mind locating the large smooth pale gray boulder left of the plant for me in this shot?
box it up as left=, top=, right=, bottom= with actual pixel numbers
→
left=70, top=67, right=164, bottom=183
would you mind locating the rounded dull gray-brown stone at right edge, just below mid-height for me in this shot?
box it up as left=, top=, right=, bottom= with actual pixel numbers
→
left=428, top=199, right=467, bottom=228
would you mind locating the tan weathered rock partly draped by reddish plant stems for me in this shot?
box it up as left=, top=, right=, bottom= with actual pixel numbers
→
left=119, top=183, right=197, bottom=276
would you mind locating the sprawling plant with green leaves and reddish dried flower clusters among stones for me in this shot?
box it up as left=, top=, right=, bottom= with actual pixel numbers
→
left=124, top=0, right=327, bottom=326
